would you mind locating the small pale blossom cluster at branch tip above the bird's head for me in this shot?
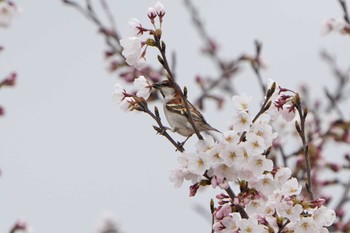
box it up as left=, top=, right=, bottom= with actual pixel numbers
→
left=120, top=2, right=165, bottom=69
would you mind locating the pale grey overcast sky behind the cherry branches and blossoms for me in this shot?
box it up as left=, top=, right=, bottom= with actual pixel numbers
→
left=0, top=0, right=350, bottom=233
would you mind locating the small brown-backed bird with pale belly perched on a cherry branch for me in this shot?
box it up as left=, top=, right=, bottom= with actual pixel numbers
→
left=152, top=80, right=220, bottom=143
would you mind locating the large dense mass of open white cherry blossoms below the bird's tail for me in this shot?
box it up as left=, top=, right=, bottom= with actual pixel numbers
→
left=170, top=84, right=335, bottom=233
